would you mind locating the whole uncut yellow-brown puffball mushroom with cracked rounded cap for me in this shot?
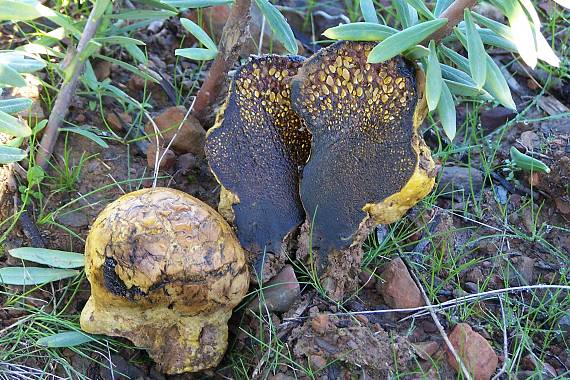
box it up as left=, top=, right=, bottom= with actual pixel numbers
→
left=81, top=188, right=249, bottom=374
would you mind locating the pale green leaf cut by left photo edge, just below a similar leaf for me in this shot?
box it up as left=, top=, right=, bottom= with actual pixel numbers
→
left=0, top=267, right=80, bottom=285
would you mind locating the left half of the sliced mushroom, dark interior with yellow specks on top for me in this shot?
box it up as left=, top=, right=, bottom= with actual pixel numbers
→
left=206, top=55, right=310, bottom=278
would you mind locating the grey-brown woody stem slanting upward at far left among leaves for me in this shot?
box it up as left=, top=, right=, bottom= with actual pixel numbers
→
left=36, top=6, right=101, bottom=169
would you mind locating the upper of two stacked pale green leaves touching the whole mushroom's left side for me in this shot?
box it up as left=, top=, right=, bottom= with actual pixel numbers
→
left=8, top=247, right=85, bottom=269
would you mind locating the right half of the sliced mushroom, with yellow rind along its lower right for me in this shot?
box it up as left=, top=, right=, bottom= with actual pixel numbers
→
left=292, top=41, right=435, bottom=294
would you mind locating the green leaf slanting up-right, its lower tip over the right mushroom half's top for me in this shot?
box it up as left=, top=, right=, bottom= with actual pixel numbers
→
left=368, top=19, right=447, bottom=63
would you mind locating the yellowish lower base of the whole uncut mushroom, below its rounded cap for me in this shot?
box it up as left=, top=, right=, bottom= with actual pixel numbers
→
left=81, top=297, right=231, bottom=374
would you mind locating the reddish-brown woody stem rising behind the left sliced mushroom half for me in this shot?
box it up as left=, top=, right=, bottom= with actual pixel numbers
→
left=192, top=0, right=251, bottom=125
